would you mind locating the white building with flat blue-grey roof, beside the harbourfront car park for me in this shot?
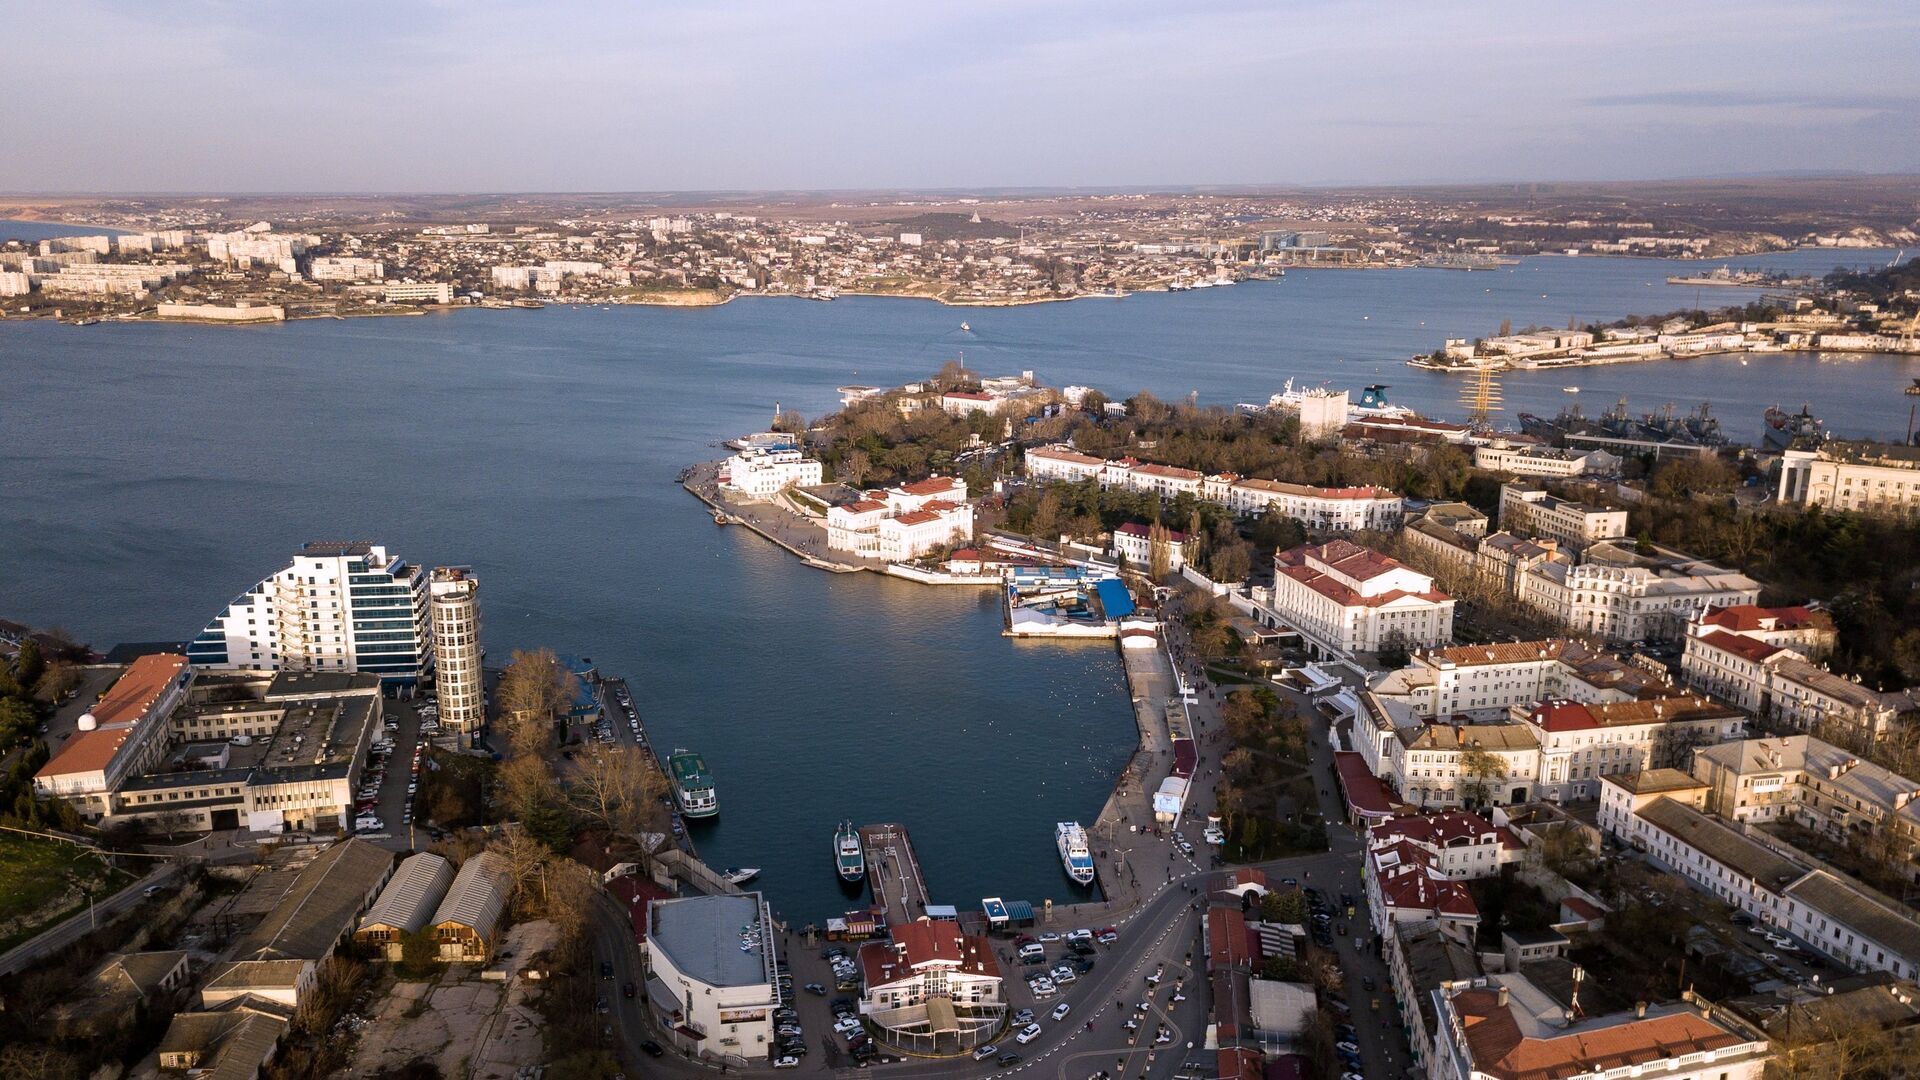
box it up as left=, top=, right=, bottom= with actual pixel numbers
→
left=641, top=892, right=780, bottom=1065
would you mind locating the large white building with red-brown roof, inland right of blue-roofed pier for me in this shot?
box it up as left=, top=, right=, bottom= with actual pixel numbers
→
left=1265, top=540, right=1453, bottom=657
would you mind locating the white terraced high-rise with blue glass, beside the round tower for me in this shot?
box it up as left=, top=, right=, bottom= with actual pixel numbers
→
left=186, top=542, right=434, bottom=684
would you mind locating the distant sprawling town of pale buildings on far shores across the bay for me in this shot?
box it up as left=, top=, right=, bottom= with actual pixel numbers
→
left=11, top=178, right=1920, bottom=320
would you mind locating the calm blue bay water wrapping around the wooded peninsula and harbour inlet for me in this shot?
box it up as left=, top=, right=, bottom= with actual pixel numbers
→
left=0, top=252, right=1920, bottom=919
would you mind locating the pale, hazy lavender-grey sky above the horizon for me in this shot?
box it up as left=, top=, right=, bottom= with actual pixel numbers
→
left=11, top=0, right=1920, bottom=194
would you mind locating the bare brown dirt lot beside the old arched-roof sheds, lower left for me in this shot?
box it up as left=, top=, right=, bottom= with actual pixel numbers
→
left=346, top=922, right=553, bottom=1080
